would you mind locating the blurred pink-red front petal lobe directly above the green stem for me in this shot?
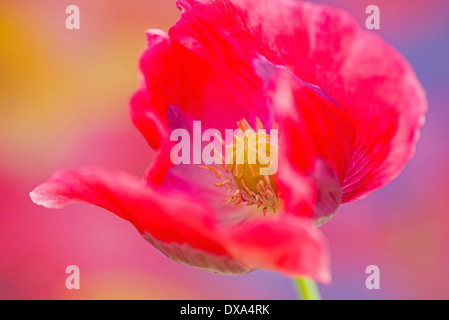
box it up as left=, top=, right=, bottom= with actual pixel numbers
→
left=226, top=214, right=330, bottom=283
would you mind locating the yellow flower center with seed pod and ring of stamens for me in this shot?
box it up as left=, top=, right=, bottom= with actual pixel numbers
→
left=202, top=118, right=278, bottom=215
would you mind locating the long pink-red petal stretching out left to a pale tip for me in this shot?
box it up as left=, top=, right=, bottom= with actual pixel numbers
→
left=30, top=168, right=251, bottom=273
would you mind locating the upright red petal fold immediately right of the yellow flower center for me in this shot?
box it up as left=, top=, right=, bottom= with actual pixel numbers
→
left=270, top=70, right=355, bottom=224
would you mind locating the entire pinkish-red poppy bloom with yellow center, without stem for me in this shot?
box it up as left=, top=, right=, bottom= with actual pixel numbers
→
left=31, top=0, right=427, bottom=282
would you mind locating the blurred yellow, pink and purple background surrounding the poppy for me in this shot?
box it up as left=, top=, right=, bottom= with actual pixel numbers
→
left=0, top=0, right=449, bottom=299
